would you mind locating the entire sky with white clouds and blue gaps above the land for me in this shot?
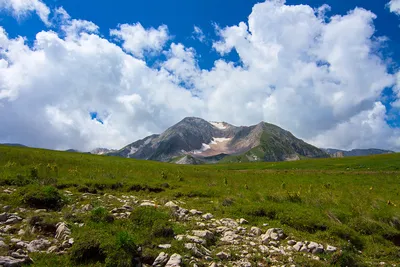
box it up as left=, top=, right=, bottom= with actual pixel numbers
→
left=0, top=0, right=400, bottom=151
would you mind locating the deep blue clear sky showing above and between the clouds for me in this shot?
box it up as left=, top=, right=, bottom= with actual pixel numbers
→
left=1, top=0, right=400, bottom=68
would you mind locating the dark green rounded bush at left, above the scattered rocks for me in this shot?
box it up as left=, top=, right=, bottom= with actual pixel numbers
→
left=21, top=186, right=65, bottom=210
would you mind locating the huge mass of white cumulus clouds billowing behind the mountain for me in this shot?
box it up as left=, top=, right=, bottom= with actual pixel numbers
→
left=0, top=0, right=400, bottom=150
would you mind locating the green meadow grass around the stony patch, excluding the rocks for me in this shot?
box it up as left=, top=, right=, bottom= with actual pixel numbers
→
left=0, top=146, right=400, bottom=266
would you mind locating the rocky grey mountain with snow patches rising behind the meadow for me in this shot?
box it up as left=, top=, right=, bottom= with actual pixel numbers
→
left=107, top=117, right=329, bottom=164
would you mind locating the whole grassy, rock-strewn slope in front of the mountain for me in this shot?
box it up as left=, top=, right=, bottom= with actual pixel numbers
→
left=0, top=146, right=400, bottom=266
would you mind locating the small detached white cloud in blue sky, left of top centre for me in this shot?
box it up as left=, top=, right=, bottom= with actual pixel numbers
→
left=110, top=23, right=169, bottom=58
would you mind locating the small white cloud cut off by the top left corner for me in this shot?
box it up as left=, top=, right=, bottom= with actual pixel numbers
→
left=0, top=0, right=50, bottom=26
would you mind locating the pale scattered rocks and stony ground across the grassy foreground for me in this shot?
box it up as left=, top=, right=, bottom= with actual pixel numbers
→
left=0, top=189, right=394, bottom=267
